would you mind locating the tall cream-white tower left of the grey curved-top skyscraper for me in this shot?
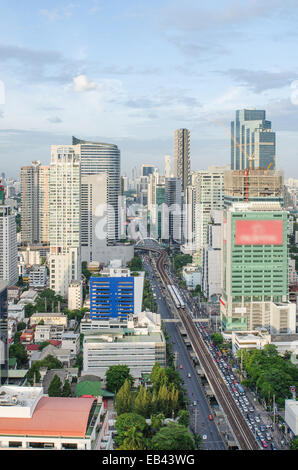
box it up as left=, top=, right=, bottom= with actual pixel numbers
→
left=49, top=145, right=81, bottom=297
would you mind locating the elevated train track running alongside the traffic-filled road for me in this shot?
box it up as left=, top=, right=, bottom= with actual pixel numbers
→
left=156, top=252, right=260, bottom=450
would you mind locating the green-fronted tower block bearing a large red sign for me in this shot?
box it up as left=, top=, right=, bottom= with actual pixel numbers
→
left=220, top=201, right=296, bottom=334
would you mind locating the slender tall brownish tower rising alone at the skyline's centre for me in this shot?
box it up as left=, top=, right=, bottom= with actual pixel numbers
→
left=174, top=129, right=190, bottom=192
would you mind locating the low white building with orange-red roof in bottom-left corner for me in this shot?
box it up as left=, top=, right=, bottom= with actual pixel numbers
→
left=0, top=386, right=112, bottom=450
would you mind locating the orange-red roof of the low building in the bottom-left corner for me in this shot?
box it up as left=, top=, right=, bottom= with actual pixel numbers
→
left=0, top=397, right=94, bottom=437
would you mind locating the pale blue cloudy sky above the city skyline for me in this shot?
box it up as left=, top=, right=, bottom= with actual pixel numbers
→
left=0, top=0, right=298, bottom=178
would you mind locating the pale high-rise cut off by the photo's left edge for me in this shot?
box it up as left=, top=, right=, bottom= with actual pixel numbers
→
left=0, top=181, right=19, bottom=287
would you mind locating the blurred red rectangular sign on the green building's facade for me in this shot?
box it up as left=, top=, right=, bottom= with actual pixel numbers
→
left=235, top=220, right=283, bottom=245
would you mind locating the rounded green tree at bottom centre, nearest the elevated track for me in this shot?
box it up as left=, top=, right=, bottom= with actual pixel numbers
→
left=151, top=422, right=195, bottom=450
